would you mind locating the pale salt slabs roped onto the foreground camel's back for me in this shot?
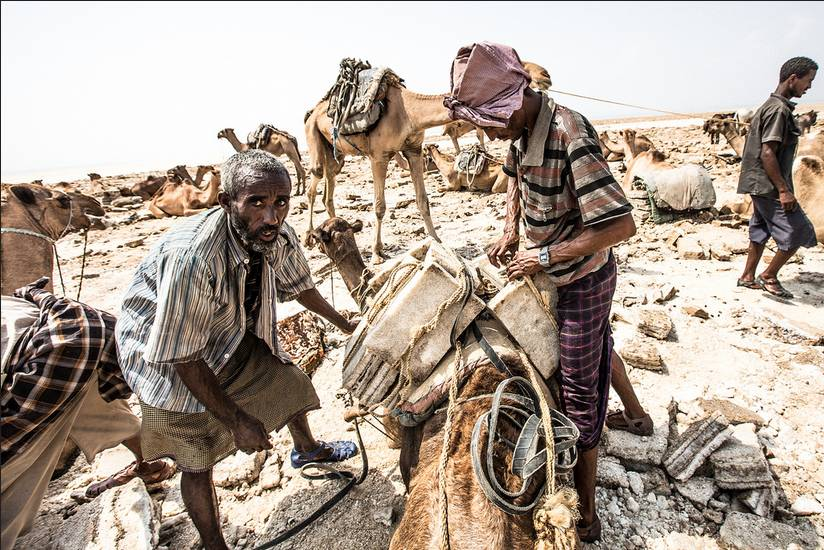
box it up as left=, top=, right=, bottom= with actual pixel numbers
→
left=343, top=240, right=558, bottom=408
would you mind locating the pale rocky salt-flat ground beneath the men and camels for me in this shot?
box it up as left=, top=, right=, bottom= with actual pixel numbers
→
left=9, top=114, right=824, bottom=550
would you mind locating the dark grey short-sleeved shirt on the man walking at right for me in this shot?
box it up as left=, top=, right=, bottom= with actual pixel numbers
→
left=738, top=94, right=799, bottom=197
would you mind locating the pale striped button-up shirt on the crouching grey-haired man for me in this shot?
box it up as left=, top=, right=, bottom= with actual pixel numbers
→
left=116, top=207, right=314, bottom=412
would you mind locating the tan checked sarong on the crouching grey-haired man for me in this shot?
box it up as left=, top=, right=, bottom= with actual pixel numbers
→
left=140, top=332, right=320, bottom=472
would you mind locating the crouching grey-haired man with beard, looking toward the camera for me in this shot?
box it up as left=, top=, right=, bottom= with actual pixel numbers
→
left=116, top=149, right=357, bottom=550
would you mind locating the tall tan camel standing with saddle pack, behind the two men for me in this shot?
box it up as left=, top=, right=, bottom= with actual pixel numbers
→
left=305, top=83, right=450, bottom=263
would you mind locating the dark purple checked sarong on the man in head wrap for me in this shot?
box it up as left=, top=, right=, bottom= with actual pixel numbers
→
left=556, top=253, right=617, bottom=451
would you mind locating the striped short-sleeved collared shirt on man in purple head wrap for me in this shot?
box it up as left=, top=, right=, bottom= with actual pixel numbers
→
left=503, top=95, right=632, bottom=286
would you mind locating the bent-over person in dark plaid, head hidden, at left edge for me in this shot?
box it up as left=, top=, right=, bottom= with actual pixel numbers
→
left=0, top=277, right=175, bottom=550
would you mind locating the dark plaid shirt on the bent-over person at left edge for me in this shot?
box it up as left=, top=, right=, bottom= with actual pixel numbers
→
left=0, top=278, right=132, bottom=464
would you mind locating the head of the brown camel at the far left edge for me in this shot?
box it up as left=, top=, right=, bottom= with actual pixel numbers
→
left=3, top=183, right=106, bottom=239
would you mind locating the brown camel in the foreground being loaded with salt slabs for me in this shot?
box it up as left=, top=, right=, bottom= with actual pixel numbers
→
left=311, top=217, right=560, bottom=550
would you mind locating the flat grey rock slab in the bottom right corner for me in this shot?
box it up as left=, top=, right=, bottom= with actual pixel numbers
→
left=719, top=512, right=815, bottom=550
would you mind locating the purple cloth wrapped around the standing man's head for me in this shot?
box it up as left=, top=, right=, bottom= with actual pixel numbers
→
left=443, top=42, right=531, bottom=128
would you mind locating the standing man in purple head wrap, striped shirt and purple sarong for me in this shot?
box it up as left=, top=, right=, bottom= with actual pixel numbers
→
left=444, top=42, right=652, bottom=542
